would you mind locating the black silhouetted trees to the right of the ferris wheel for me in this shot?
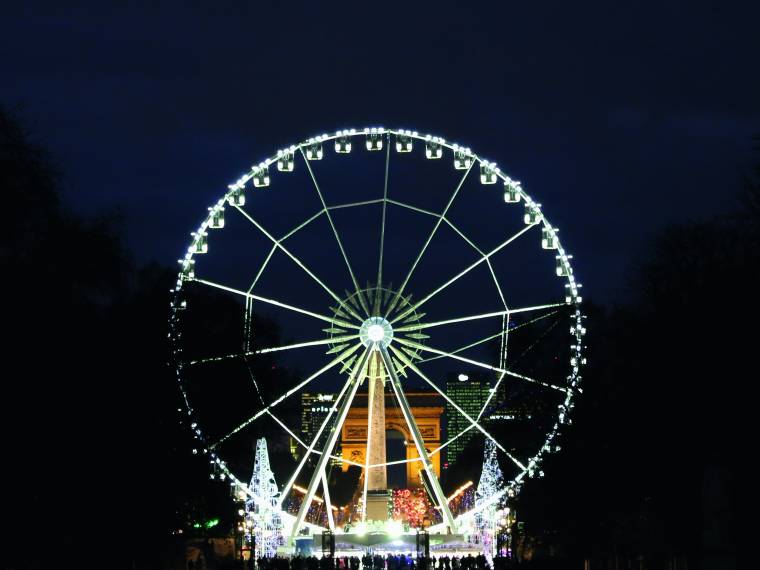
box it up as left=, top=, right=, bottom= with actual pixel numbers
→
left=508, top=166, right=760, bottom=568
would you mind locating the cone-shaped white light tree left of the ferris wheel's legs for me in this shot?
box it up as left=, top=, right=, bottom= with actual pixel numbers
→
left=244, top=437, right=283, bottom=558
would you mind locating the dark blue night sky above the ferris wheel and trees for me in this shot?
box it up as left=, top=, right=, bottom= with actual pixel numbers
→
left=0, top=1, right=760, bottom=301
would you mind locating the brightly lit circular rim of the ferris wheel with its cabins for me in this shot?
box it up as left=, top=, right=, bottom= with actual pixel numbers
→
left=170, top=127, right=585, bottom=536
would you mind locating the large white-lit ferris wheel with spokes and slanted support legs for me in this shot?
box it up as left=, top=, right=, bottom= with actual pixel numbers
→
left=169, top=128, right=585, bottom=540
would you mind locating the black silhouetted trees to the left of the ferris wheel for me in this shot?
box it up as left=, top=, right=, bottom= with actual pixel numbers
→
left=0, top=104, right=228, bottom=568
